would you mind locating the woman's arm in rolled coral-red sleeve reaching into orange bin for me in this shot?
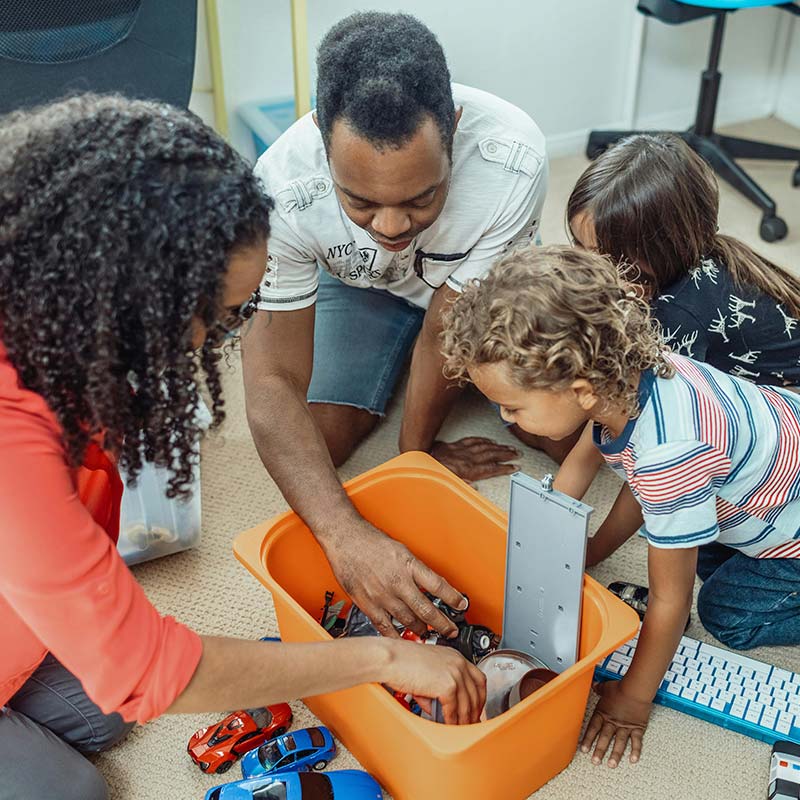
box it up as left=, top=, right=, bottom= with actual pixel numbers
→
left=0, top=409, right=484, bottom=722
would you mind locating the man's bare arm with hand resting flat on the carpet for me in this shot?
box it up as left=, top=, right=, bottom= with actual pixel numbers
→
left=399, top=286, right=520, bottom=481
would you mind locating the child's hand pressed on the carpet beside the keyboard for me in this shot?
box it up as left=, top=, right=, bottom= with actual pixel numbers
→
left=581, top=679, right=653, bottom=768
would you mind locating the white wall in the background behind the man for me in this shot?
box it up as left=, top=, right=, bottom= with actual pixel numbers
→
left=193, top=0, right=800, bottom=161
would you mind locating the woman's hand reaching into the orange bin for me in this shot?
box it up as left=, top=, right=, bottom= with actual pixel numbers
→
left=386, top=641, right=486, bottom=725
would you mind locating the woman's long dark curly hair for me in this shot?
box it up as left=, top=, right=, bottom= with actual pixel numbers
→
left=0, top=94, right=272, bottom=496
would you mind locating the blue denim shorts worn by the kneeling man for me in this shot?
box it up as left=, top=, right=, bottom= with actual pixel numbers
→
left=308, top=270, right=425, bottom=416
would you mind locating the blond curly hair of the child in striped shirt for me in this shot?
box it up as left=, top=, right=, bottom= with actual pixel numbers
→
left=442, top=246, right=673, bottom=417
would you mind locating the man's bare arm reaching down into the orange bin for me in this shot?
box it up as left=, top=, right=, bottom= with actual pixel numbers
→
left=242, top=307, right=463, bottom=636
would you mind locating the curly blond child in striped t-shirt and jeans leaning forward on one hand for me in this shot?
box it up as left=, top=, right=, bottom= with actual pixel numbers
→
left=443, top=247, right=800, bottom=766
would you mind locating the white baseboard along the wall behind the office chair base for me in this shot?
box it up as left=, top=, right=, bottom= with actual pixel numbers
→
left=547, top=98, right=776, bottom=158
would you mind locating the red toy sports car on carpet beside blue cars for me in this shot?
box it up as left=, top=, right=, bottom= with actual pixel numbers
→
left=186, top=703, right=292, bottom=775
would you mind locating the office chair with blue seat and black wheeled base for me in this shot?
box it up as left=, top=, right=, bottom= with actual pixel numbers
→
left=586, top=0, right=800, bottom=242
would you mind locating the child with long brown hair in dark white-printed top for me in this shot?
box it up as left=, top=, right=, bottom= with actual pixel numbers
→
left=567, top=134, right=800, bottom=386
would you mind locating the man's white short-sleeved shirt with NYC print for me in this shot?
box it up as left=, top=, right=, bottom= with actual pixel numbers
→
left=255, top=84, right=547, bottom=311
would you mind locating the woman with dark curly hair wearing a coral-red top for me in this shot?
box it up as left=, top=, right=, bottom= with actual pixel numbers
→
left=0, top=95, right=484, bottom=800
